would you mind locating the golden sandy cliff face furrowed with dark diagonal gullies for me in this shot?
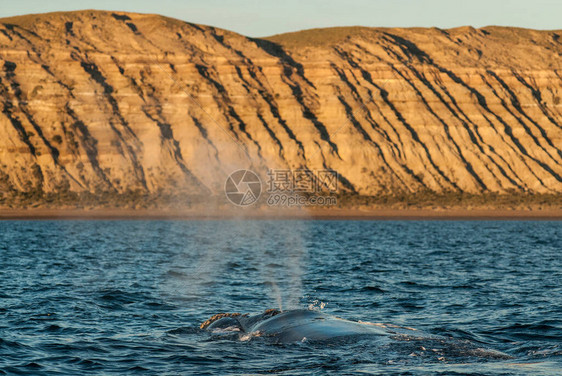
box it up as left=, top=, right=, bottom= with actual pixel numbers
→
left=0, top=11, right=562, bottom=203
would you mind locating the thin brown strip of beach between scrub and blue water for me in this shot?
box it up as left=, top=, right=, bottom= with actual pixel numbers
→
left=0, top=208, right=562, bottom=221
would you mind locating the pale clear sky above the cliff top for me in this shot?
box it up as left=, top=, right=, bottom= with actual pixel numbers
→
left=0, top=0, right=562, bottom=37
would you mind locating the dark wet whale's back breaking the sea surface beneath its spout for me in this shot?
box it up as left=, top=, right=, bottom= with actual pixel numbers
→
left=200, top=309, right=512, bottom=359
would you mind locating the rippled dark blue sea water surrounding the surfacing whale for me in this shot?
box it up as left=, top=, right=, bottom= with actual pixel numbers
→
left=0, top=220, right=562, bottom=375
